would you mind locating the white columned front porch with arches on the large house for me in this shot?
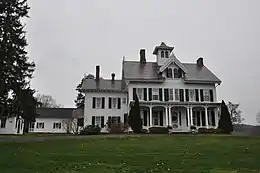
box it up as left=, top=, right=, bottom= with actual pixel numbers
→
left=140, top=104, right=219, bottom=132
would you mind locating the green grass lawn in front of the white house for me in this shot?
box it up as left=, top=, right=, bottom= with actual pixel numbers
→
left=0, top=136, right=260, bottom=173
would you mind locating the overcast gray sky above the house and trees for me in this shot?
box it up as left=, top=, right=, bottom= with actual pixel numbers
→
left=27, top=0, right=260, bottom=124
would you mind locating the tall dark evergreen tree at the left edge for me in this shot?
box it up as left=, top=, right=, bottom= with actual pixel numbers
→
left=0, top=0, right=37, bottom=131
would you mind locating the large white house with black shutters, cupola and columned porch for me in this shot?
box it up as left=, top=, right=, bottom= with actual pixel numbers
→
left=82, top=42, right=221, bottom=132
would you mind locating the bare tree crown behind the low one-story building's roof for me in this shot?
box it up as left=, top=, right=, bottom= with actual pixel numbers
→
left=36, top=94, right=63, bottom=108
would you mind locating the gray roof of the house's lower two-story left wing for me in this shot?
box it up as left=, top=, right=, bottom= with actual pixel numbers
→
left=81, top=78, right=123, bottom=92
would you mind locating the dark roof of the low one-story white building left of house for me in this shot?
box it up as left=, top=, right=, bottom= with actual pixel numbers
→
left=36, top=108, right=76, bottom=119
